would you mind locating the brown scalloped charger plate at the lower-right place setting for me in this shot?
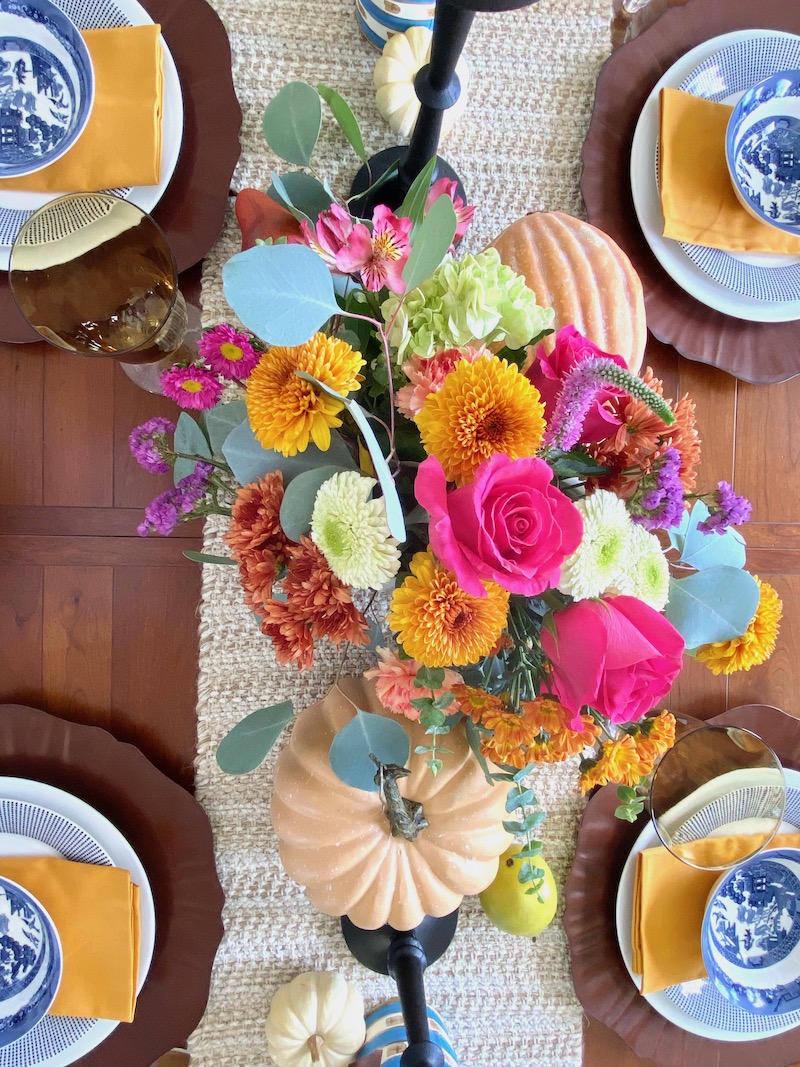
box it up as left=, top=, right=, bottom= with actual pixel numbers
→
left=564, top=704, right=800, bottom=1067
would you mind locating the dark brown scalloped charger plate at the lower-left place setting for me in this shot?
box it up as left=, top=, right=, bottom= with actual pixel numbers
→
left=0, top=704, right=224, bottom=1067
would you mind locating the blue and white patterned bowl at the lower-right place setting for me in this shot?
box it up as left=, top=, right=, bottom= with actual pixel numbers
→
left=702, top=848, right=800, bottom=1015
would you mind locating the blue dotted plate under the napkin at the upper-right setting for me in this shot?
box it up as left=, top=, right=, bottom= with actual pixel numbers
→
left=678, top=33, right=800, bottom=303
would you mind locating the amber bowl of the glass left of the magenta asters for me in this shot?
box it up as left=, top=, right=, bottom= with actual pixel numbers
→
left=9, top=193, right=188, bottom=377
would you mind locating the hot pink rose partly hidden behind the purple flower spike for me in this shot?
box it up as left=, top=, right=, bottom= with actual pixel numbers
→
left=525, top=325, right=627, bottom=444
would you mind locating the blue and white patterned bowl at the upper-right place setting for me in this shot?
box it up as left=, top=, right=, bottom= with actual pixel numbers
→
left=725, top=70, right=800, bottom=235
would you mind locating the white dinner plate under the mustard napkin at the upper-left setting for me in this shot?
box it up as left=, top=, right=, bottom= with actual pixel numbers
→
left=0, top=0, right=183, bottom=270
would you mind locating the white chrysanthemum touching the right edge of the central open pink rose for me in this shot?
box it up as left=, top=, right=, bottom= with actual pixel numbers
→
left=558, top=489, right=634, bottom=600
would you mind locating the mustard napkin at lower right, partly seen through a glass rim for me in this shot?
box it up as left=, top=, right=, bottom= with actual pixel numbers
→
left=630, top=833, right=800, bottom=993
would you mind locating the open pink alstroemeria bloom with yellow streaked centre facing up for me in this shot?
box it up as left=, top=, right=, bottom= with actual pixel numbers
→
left=336, top=204, right=411, bottom=293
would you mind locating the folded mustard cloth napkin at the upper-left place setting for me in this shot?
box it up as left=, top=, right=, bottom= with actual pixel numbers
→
left=0, top=25, right=163, bottom=192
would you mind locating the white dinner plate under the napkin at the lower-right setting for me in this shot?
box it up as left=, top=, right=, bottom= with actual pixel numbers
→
left=617, top=770, right=800, bottom=1041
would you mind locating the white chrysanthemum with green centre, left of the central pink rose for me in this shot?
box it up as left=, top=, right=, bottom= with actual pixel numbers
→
left=311, top=471, right=400, bottom=589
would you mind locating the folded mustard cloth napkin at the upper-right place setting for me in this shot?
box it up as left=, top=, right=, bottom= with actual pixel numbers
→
left=658, top=89, right=800, bottom=255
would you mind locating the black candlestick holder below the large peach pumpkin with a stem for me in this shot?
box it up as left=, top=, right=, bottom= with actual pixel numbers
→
left=341, top=909, right=459, bottom=1067
